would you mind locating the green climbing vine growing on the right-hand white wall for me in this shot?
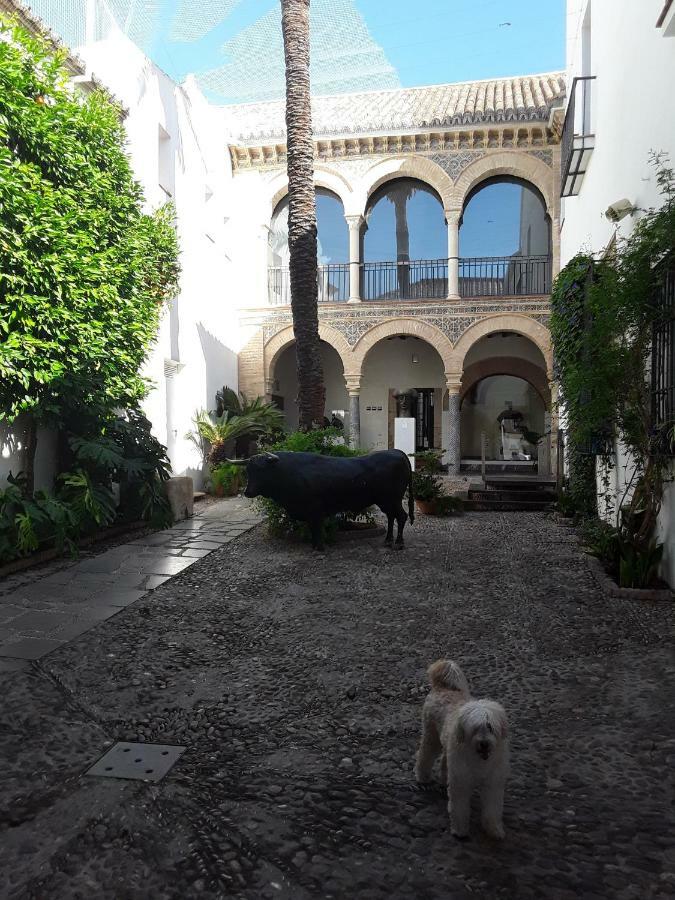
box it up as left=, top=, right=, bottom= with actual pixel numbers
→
left=551, top=154, right=675, bottom=586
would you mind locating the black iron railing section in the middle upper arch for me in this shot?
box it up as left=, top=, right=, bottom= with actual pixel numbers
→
left=361, top=259, right=448, bottom=300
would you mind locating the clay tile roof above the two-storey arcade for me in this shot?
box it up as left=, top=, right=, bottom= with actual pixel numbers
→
left=223, top=72, right=565, bottom=145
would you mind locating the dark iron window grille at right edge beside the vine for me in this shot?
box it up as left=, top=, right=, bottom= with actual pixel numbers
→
left=652, top=259, right=675, bottom=446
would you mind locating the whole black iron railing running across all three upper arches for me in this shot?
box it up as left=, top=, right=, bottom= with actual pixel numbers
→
left=267, top=256, right=551, bottom=306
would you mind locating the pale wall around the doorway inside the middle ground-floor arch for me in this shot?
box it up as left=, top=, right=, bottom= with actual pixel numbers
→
left=361, top=337, right=445, bottom=450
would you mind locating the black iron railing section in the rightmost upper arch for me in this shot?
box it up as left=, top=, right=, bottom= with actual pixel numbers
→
left=459, top=256, right=551, bottom=297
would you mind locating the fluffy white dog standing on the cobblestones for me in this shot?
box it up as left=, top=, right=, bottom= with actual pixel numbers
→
left=415, top=659, right=509, bottom=838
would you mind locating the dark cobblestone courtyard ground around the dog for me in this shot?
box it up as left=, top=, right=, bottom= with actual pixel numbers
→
left=0, top=513, right=675, bottom=900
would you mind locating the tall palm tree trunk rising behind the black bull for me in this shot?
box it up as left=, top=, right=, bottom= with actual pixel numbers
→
left=281, top=0, right=326, bottom=431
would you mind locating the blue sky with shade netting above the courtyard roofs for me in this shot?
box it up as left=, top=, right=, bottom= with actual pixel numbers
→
left=59, top=0, right=565, bottom=103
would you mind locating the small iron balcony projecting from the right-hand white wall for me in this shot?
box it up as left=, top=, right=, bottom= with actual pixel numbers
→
left=560, top=75, right=595, bottom=197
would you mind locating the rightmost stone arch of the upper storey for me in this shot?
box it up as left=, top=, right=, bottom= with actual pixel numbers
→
left=447, top=150, right=556, bottom=220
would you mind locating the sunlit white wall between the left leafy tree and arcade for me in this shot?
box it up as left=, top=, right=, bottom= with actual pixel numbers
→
left=78, top=30, right=238, bottom=486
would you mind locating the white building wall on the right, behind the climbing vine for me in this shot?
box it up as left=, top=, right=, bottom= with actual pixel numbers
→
left=561, top=0, right=675, bottom=585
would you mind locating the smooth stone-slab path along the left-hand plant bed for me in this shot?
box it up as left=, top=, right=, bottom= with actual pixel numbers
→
left=0, top=497, right=260, bottom=671
